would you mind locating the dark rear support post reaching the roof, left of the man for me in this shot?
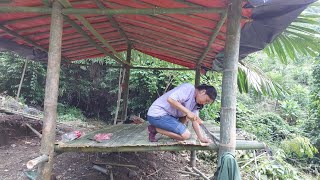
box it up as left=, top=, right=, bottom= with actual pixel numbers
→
left=121, top=43, right=132, bottom=121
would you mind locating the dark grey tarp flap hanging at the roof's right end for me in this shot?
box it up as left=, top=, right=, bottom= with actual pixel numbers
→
left=212, top=0, right=316, bottom=71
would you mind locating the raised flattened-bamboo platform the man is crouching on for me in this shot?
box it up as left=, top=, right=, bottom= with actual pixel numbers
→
left=55, top=122, right=265, bottom=152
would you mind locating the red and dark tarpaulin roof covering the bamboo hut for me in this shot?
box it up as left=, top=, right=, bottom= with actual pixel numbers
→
left=0, top=0, right=315, bottom=69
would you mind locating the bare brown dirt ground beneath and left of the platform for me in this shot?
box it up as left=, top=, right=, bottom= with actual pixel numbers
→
left=0, top=113, right=215, bottom=180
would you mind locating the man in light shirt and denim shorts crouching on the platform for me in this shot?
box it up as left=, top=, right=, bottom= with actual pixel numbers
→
left=147, top=83, right=217, bottom=143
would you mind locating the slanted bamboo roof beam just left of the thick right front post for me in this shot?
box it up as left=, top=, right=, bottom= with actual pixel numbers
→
left=196, top=11, right=228, bottom=66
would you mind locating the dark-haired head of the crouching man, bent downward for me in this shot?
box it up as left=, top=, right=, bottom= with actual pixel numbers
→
left=196, top=84, right=217, bottom=105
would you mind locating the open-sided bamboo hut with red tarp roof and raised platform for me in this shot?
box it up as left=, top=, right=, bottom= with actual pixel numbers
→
left=0, top=0, right=315, bottom=179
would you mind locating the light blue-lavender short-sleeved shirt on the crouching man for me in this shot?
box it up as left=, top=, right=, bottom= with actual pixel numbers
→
left=148, top=83, right=198, bottom=118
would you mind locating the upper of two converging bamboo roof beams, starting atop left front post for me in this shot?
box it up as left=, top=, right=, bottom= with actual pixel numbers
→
left=58, top=0, right=126, bottom=65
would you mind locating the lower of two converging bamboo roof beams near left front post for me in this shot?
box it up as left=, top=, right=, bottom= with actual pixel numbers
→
left=64, top=16, right=127, bottom=64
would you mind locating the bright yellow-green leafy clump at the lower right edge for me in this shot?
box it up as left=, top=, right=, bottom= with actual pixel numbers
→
left=281, top=136, right=318, bottom=158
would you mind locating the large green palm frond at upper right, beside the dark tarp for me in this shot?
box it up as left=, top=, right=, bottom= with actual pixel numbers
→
left=263, top=13, right=320, bottom=64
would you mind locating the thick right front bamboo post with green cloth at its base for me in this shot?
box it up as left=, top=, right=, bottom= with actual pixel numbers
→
left=218, top=0, right=242, bottom=159
